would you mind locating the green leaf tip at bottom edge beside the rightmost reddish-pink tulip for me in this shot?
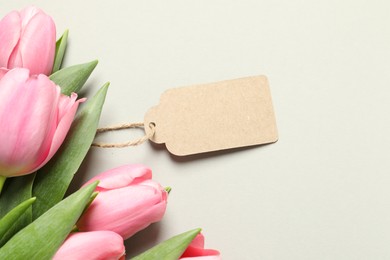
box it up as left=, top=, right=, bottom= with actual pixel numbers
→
left=132, top=228, right=201, bottom=260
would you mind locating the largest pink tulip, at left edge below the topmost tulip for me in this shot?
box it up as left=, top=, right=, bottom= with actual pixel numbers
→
left=0, top=68, right=84, bottom=177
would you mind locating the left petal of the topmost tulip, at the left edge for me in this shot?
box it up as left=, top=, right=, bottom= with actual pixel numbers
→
left=0, top=11, right=21, bottom=68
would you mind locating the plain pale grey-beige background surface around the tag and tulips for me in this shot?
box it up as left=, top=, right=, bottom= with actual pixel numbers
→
left=0, top=0, right=390, bottom=260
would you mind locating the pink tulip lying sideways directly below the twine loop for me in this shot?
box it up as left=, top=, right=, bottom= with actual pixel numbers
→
left=77, top=165, right=168, bottom=239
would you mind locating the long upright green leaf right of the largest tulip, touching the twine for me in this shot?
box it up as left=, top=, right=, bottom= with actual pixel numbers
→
left=32, top=83, right=109, bottom=219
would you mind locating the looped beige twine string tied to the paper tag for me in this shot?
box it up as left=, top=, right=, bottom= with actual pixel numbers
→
left=92, top=122, right=155, bottom=148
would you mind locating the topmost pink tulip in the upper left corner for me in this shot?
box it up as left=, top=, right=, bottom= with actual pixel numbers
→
left=0, top=7, right=56, bottom=75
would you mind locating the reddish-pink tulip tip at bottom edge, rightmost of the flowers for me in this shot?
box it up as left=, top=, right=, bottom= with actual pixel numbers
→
left=180, top=234, right=222, bottom=260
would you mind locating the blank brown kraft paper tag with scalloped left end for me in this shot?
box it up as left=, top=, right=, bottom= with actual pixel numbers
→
left=145, top=76, right=278, bottom=156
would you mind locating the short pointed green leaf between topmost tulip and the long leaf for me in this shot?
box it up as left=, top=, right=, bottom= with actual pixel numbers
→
left=50, top=60, right=98, bottom=95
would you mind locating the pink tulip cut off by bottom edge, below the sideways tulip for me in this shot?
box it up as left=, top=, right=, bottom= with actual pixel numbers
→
left=53, top=231, right=125, bottom=260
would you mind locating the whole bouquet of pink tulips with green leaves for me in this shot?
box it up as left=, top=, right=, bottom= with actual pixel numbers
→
left=0, top=7, right=221, bottom=260
